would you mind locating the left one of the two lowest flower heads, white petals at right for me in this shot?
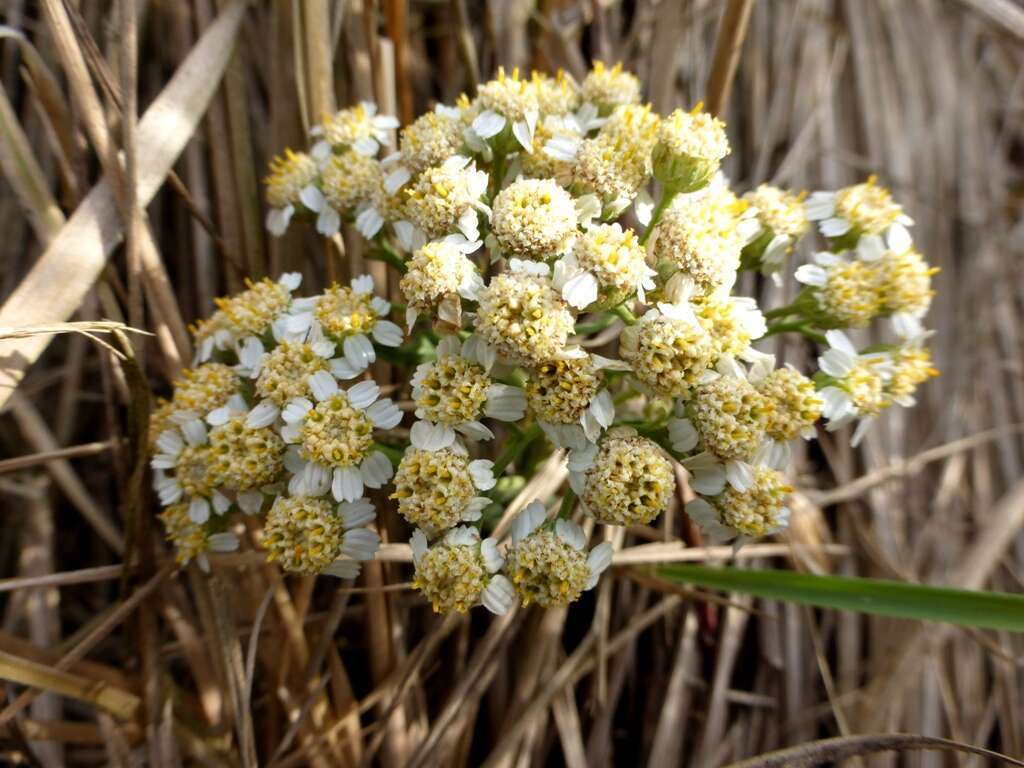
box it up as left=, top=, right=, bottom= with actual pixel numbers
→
left=410, top=525, right=515, bottom=613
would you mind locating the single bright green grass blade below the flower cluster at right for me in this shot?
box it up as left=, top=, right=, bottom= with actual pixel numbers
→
left=658, top=565, right=1024, bottom=632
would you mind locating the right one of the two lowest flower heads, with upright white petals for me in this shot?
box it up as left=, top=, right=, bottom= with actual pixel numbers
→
left=505, top=502, right=611, bottom=607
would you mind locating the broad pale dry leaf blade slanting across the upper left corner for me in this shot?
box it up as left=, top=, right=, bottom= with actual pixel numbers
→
left=0, top=0, right=246, bottom=406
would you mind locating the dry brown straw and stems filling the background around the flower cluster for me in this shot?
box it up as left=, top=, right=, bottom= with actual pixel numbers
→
left=0, top=0, right=1024, bottom=768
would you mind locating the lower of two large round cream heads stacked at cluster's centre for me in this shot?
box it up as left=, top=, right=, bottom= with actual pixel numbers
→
left=476, top=270, right=574, bottom=365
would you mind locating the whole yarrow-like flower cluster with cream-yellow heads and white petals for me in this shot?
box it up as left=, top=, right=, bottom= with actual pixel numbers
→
left=153, top=63, right=937, bottom=613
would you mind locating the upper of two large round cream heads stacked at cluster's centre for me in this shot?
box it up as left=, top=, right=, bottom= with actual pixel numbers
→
left=490, top=179, right=578, bottom=261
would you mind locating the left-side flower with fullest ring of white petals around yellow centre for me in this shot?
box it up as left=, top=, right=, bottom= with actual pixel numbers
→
left=281, top=371, right=401, bottom=502
